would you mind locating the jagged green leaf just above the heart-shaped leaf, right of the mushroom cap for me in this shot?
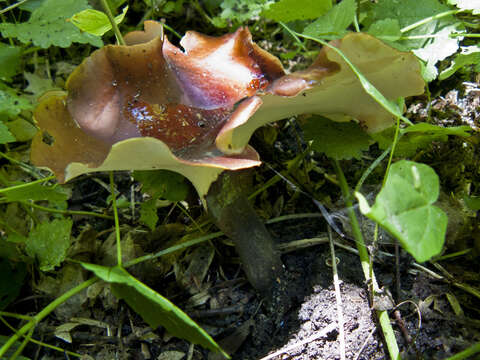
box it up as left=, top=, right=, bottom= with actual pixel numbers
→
left=372, top=123, right=471, bottom=157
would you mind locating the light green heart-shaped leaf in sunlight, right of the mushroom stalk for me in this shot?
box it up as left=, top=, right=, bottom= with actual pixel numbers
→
left=355, top=160, right=448, bottom=262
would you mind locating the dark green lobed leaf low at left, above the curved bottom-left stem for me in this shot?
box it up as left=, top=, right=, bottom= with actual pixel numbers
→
left=25, top=219, right=73, bottom=271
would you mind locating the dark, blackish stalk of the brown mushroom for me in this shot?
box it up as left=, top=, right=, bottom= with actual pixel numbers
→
left=206, top=170, right=283, bottom=297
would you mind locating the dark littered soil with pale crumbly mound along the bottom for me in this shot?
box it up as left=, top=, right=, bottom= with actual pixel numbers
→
left=11, top=211, right=480, bottom=360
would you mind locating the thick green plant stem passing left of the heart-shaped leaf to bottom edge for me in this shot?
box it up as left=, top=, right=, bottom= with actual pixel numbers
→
left=333, top=160, right=400, bottom=360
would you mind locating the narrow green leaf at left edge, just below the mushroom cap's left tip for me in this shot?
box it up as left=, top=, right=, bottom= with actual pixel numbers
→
left=0, top=183, right=69, bottom=201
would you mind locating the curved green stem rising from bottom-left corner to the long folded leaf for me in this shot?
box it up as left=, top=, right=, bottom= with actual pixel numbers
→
left=0, top=276, right=99, bottom=359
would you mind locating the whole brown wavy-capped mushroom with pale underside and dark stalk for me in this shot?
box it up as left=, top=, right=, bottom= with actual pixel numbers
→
left=31, top=21, right=423, bottom=295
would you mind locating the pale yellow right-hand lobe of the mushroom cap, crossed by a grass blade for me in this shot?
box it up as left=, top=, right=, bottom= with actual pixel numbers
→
left=216, top=33, right=424, bottom=153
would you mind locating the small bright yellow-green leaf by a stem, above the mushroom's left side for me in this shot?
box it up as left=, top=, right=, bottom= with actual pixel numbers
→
left=70, top=6, right=128, bottom=36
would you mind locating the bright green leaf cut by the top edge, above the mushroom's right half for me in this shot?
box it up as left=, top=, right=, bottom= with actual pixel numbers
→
left=262, top=0, right=332, bottom=22
